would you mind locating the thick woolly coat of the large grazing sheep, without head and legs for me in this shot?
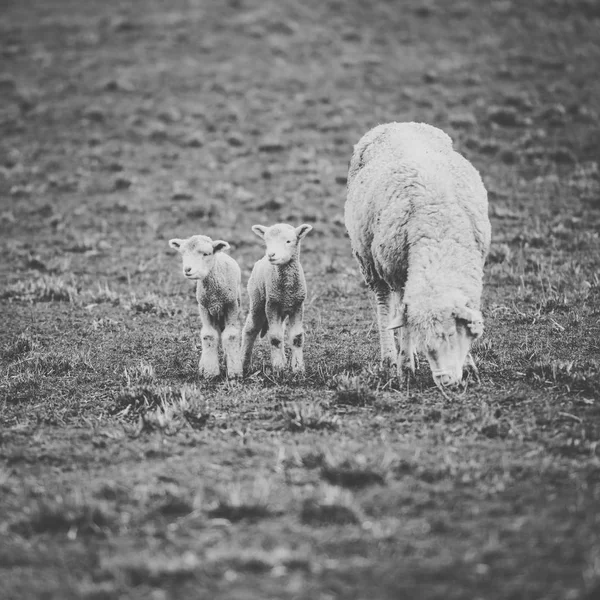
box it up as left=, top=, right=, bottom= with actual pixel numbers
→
left=345, top=123, right=491, bottom=338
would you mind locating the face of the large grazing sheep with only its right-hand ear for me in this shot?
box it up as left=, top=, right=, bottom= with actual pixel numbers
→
left=425, top=307, right=483, bottom=387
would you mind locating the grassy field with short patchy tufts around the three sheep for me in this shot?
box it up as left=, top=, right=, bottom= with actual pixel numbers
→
left=0, top=0, right=600, bottom=600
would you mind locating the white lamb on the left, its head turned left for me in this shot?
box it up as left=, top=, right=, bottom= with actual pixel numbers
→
left=169, top=235, right=242, bottom=377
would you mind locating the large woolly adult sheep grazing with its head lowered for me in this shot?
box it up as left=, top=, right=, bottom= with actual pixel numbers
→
left=345, top=123, right=491, bottom=391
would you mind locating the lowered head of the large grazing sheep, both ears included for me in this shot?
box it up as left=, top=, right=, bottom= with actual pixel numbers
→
left=389, top=297, right=483, bottom=388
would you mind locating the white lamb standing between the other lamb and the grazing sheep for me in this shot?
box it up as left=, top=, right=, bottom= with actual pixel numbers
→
left=242, top=223, right=312, bottom=373
